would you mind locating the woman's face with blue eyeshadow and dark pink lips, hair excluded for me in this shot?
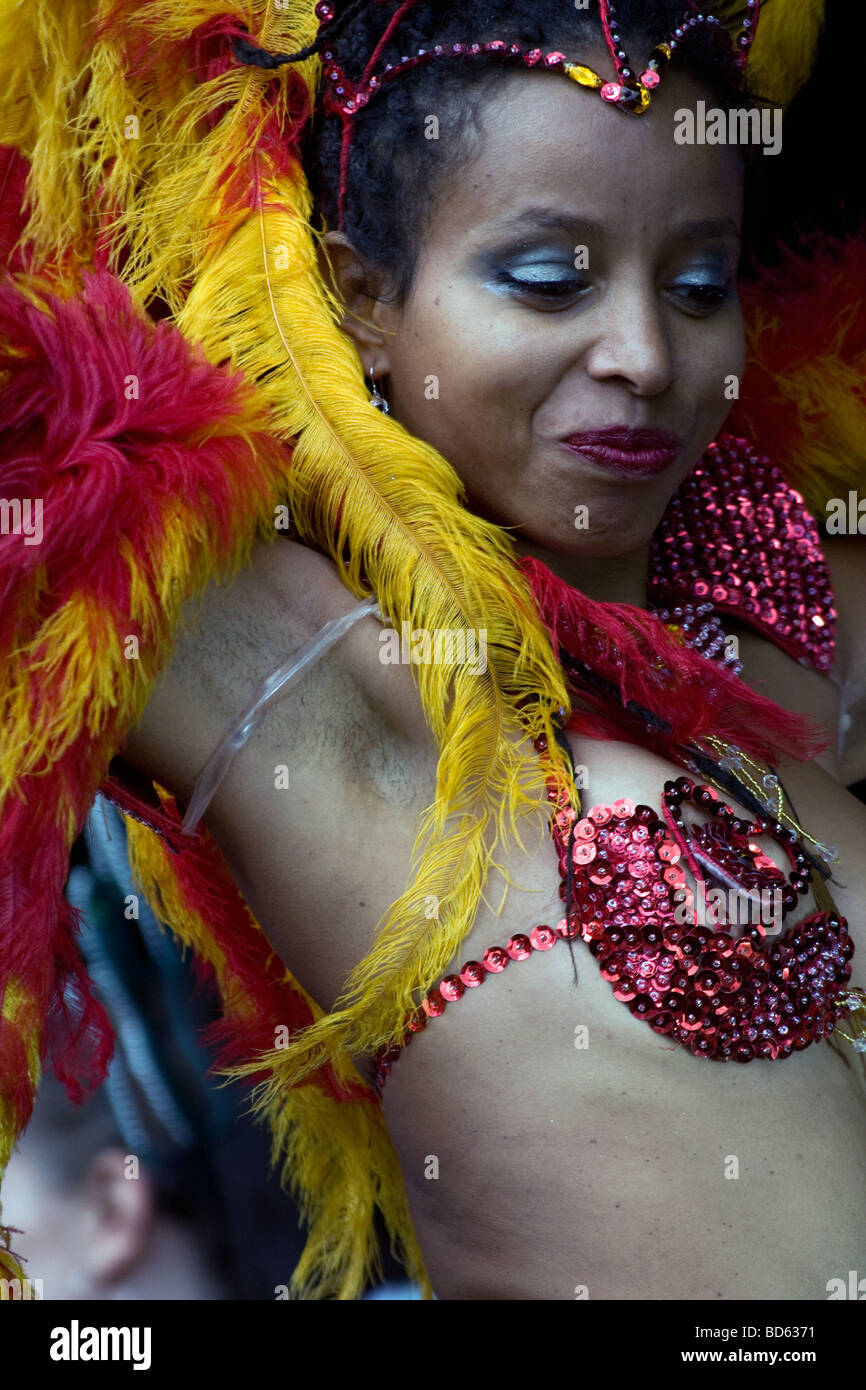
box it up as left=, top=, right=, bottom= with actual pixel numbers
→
left=330, top=59, right=744, bottom=559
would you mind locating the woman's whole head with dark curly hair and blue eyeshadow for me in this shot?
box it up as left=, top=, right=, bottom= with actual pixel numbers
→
left=309, top=3, right=767, bottom=575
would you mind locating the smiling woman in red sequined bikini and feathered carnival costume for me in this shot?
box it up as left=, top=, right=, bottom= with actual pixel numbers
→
left=0, top=3, right=866, bottom=1300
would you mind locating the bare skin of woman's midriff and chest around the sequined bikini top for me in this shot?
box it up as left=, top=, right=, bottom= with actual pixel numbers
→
left=384, top=741, right=866, bottom=1298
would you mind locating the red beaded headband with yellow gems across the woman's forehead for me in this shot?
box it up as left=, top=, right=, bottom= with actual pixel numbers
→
left=232, top=0, right=760, bottom=229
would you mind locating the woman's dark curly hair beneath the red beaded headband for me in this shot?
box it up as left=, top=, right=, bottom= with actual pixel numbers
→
left=255, top=0, right=760, bottom=304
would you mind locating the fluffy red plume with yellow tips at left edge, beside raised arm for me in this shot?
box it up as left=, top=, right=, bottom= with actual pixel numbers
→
left=0, top=272, right=293, bottom=1289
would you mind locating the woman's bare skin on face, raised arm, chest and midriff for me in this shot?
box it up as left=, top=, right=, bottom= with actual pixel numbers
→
left=126, top=56, right=866, bottom=1300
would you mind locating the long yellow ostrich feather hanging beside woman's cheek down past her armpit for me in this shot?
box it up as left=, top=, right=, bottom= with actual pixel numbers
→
left=178, top=159, right=567, bottom=1070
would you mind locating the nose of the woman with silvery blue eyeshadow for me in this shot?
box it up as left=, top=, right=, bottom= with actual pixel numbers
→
left=585, top=285, right=674, bottom=396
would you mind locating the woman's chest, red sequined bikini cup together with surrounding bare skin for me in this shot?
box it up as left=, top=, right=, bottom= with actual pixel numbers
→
left=383, top=737, right=866, bottom=1078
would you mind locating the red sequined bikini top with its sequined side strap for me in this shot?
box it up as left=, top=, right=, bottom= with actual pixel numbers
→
left=375, top=777, right=866, bottom=1094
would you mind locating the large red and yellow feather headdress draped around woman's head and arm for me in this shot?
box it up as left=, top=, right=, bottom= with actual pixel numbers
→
left=0, top=0, right=863, bottom=1298
